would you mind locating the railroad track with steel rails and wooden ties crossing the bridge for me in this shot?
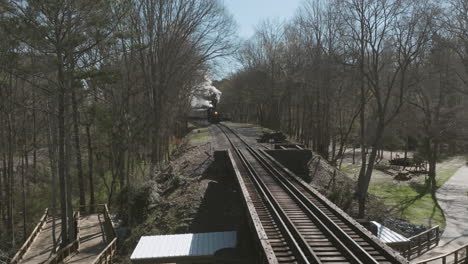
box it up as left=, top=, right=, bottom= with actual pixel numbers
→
left=218, top=124, right=407, bottom=264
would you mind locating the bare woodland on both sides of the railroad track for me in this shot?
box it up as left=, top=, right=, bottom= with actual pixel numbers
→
left=0, top=0, right=468, bottom=259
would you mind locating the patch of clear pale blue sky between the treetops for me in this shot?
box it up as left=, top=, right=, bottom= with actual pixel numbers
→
left=224, top=0, right=302, bottom=39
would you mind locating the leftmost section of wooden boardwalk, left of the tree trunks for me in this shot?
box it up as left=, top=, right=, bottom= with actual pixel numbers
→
left=20, top=217, right=60, bottom=264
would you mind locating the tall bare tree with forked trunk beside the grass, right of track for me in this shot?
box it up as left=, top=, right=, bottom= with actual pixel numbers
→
left=341, top=0, right=434, bottom=217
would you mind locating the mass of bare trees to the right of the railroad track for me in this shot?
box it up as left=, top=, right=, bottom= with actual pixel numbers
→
left=217, top=0, right=468, bottom=217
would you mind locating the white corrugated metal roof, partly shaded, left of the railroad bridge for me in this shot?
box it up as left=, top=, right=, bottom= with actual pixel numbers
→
left=130, top=232, right=237, bottom=260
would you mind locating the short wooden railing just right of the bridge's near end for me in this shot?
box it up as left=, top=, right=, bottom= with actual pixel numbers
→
left=396, top=226, right=440, bottom=260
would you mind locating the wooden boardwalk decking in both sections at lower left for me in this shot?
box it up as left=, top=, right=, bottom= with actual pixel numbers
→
left=10, top=204, right=117, bottom=264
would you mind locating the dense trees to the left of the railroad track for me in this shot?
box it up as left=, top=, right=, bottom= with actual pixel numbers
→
left=0, top=0, right=235, bottom=256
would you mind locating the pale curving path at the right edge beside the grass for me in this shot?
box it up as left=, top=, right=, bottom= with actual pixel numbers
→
left=418, top=166, right=468, bottom=260
